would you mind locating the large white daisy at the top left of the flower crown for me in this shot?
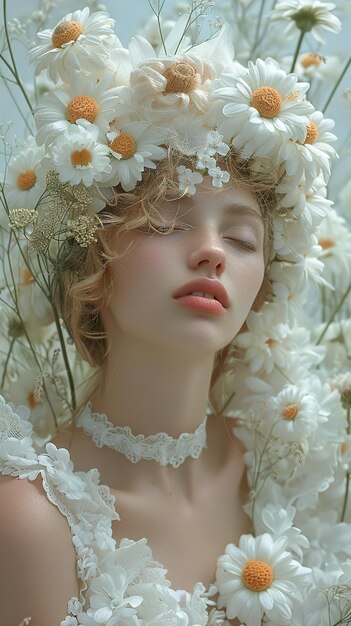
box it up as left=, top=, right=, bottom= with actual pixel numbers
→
left=29, top=7, right=115, bottom=83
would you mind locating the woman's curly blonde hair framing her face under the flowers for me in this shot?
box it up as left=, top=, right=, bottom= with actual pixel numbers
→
left=57, top=149, right=279, bottom=414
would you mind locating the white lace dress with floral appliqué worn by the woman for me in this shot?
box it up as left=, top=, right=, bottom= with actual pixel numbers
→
left=0, top=396, right=228, bottom=626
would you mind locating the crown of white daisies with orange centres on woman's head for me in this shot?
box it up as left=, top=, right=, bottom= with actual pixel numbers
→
left=7, top=8, right=336, bottom=279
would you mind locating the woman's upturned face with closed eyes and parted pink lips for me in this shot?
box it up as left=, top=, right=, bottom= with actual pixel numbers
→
left=102, top=177, right=265, bottom=355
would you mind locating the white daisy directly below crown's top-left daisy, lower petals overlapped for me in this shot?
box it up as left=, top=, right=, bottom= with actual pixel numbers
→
left=34, top=74, right=119, bottom=145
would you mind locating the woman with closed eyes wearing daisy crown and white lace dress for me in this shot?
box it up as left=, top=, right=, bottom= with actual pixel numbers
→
left=1, top=4, right=343, bottom=626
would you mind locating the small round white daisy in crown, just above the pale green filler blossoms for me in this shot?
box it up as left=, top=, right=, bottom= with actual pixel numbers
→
left=48, top=124, right=111, bottom=187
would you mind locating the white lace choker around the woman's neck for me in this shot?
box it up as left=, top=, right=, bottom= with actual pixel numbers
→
left=76, top=402, right=207, bottom=467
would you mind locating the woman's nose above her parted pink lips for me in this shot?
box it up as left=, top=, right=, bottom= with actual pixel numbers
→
left=189, top=231, right=226, bottom=276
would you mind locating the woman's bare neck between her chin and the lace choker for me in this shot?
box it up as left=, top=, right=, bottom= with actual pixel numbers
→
left=91, top=336, right=213, bottom=437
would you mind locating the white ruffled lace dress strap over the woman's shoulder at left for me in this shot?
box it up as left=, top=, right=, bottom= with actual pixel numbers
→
left=0, top=396, right=118, bottom=595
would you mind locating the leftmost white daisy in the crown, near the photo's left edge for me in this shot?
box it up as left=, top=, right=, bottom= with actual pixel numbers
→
left=5, top=137, right=45, bottom=209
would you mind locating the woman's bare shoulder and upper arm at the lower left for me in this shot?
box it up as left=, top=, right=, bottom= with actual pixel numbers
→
left=0, top=476, right=79, bottom=626
